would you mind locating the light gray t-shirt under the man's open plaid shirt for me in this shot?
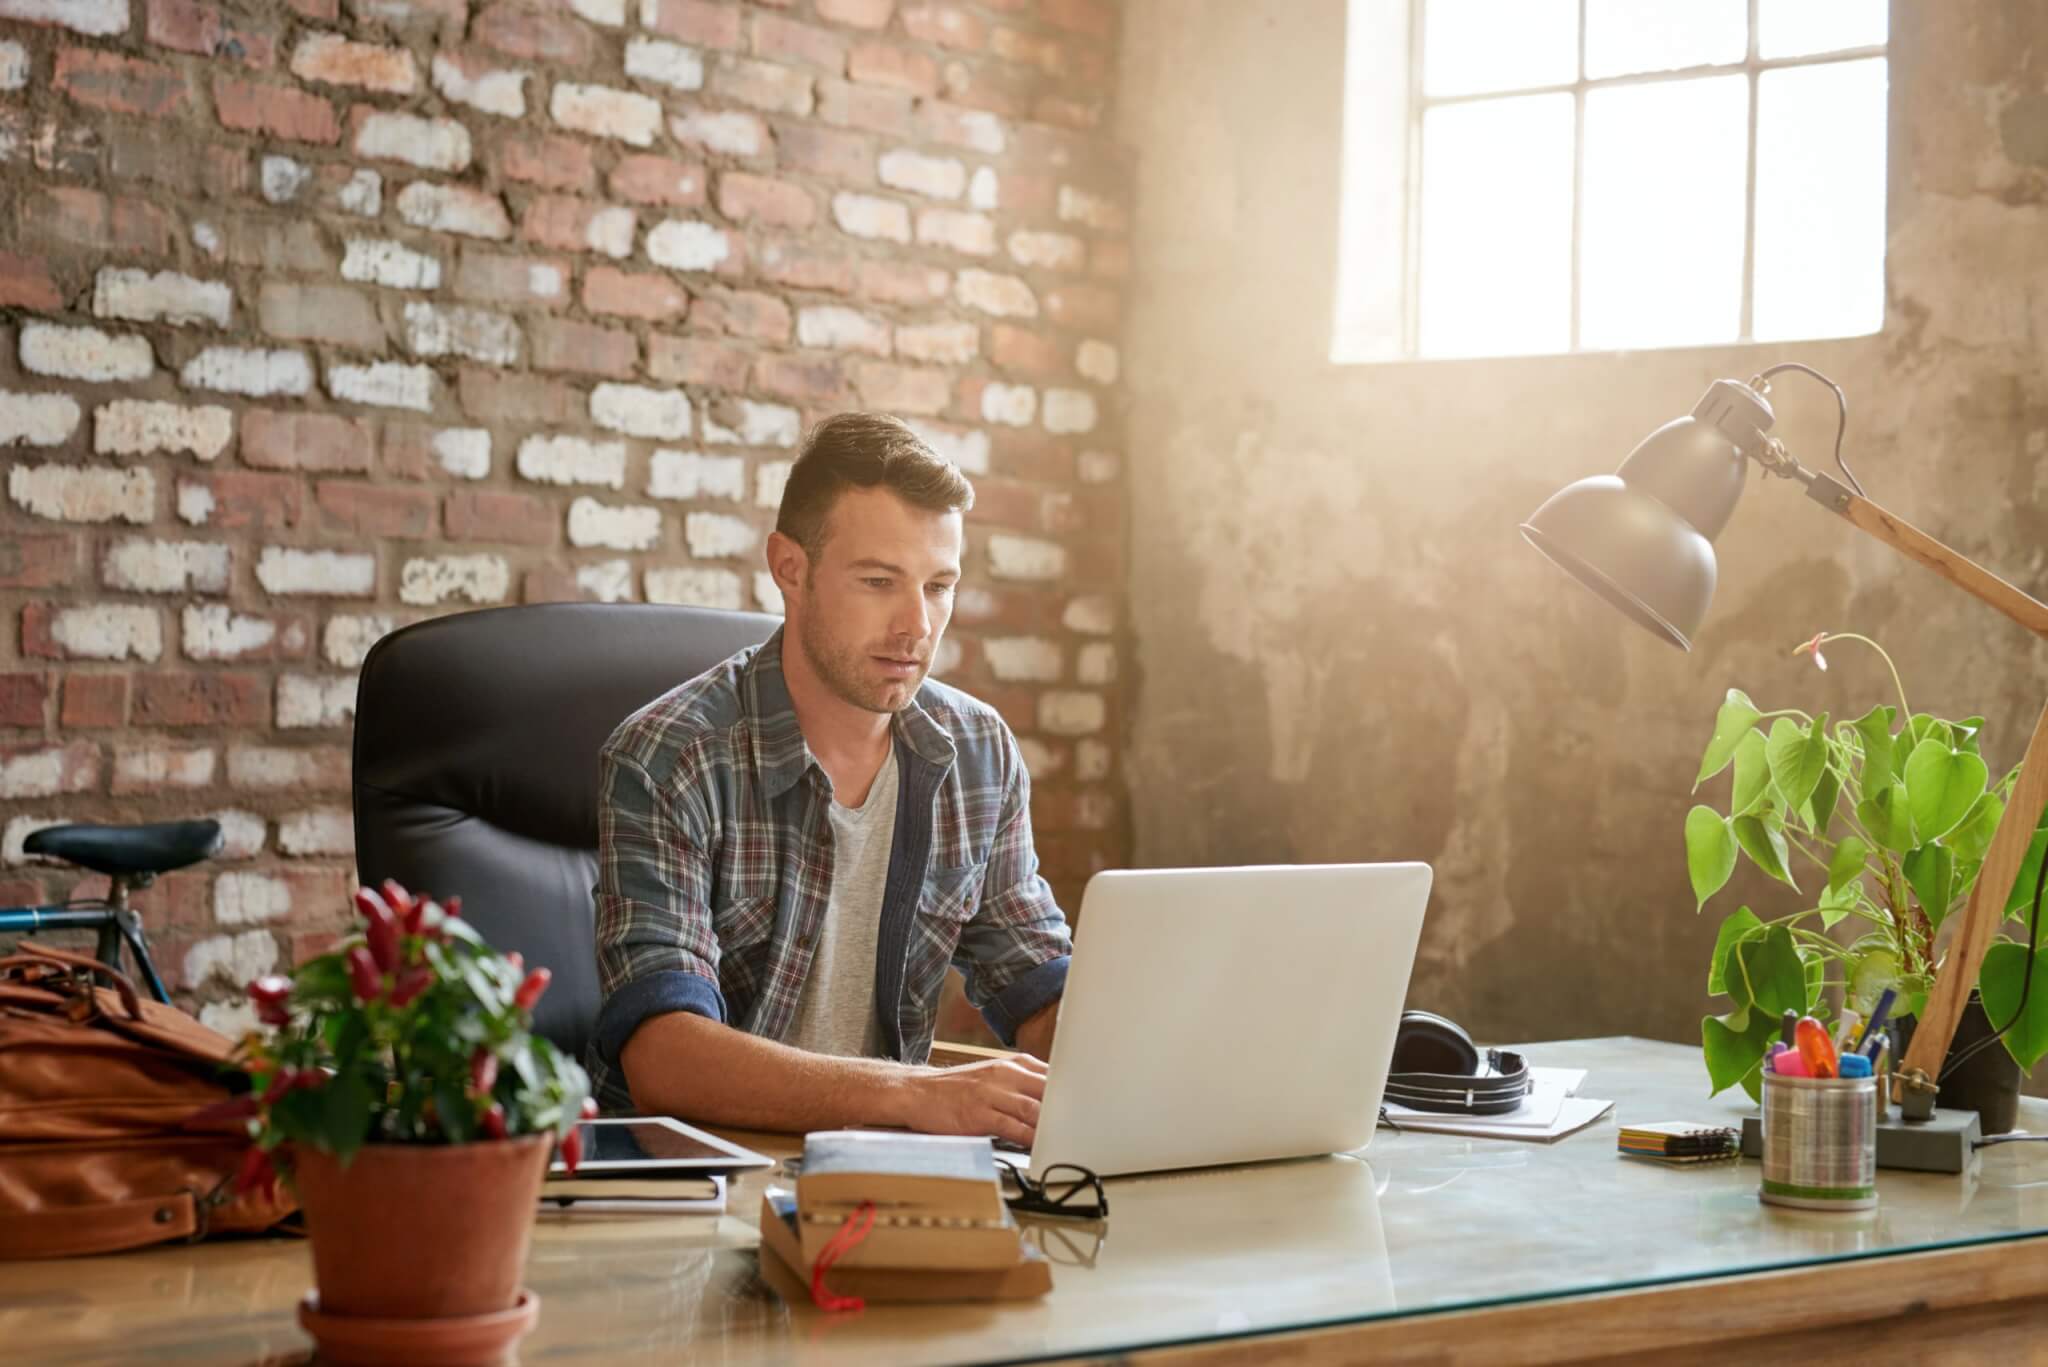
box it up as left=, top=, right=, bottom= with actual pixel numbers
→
left=784, top=744, right=897, bottom=1058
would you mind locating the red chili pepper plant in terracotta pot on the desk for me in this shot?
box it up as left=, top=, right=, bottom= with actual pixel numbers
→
left=240, top=881, right=596, bottom=1361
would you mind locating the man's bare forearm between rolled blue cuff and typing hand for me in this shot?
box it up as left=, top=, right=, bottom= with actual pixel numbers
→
left=618, top=1010, right=918, bottom=1133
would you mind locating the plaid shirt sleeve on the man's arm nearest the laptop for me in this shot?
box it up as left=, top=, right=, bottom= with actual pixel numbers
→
left=952, top=730, right=1073, bottom=1045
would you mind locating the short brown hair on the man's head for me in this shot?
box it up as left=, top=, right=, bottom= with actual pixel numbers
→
left=774, top=412, right=975, bottom=560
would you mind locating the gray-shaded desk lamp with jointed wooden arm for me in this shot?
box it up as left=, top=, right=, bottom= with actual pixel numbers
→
left=1522, top=361, right=2048, bottom=1121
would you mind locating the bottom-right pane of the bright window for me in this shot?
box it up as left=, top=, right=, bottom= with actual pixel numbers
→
left=1753, top=57, right=1886, bottom=340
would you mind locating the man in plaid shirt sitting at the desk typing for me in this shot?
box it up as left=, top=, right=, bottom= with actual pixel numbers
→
left=592, top=414, right=1073, bottom=1146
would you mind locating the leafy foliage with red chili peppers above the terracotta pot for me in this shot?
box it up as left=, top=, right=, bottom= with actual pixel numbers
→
left=227, top=881, right=596, bottom=1189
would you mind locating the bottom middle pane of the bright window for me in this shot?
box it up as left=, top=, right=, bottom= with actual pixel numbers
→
left=1579, top=76, right=1749, bottom=350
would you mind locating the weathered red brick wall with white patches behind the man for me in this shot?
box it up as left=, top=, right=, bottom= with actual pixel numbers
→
left=0, top=0, right=1130, bottom=1021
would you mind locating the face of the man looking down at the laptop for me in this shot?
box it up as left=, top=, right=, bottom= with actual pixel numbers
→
left=778, top=486, right=961, bottom=713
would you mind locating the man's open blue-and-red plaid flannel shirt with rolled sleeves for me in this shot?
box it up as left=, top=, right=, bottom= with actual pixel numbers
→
left=588, top=631, right=1073, bottom=1111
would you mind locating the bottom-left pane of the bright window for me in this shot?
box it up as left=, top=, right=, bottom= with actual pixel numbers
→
left=1419, top=94, right=1571, bottom=357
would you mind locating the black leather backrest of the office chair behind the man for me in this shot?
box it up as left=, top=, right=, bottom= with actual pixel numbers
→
left=352, top=603, right=780, bottom=1055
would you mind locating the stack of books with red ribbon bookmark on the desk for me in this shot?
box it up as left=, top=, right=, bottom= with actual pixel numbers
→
left=762, top=1129, right=1053, bottom=1301
